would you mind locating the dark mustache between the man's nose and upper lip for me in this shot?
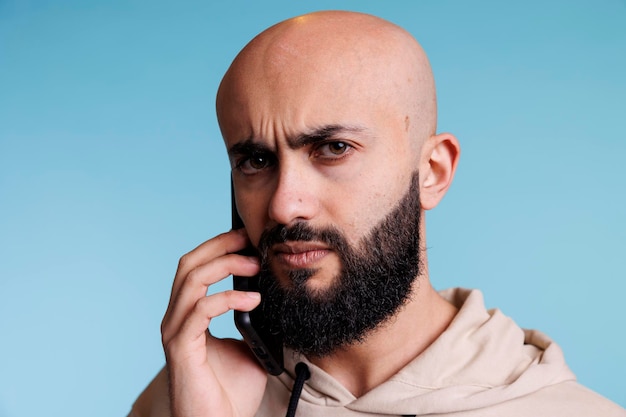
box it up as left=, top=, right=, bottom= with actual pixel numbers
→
left=258, top=222, right=347, bottom=259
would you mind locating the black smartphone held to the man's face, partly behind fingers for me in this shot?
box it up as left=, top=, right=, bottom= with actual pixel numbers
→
left=230, top=181, right=284, bottom=375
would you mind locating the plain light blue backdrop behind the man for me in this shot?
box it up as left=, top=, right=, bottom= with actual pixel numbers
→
left=0, top=0, right=626, bottom=417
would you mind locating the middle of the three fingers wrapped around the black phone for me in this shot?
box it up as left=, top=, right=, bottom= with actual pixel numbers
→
left=163, top=254, right=260, bottom=331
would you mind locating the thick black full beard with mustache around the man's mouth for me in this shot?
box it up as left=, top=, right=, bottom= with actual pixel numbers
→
left=259, top=173, right=421, bottom=357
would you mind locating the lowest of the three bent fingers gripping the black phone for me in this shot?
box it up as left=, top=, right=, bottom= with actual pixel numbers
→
left=163, top=290, right=261, bottom=356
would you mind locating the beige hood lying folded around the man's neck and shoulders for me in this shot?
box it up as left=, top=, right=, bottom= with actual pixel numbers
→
left=270, top=289, right=575, bottom=415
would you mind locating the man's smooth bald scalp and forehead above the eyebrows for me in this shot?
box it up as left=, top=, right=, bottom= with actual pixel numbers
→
left=217, top=11, right=436, bottom=148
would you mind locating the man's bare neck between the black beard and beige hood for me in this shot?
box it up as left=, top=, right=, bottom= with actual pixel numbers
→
left=310, top=276, right=457, bottom=397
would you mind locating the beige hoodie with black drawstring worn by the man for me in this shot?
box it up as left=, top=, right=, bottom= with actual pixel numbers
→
left=131, top=289, right=626, bottom=417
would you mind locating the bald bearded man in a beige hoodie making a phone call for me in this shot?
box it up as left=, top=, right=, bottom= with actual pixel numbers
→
left=131, top=12, right=626, bottom=417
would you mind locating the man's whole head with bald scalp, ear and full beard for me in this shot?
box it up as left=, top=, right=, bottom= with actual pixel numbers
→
left=217, top=11, right=458, bottom=357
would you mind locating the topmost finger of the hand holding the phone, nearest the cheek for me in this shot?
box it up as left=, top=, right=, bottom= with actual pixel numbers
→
left=172, top=229, right=250, bottom=300
